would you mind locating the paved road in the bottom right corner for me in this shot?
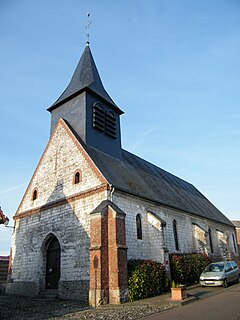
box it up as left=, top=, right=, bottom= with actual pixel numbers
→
left=143, top=286, right=240, bottom=320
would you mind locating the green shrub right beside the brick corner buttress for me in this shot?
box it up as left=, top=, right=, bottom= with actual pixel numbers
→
left=128, top=260, right=169, bottom=301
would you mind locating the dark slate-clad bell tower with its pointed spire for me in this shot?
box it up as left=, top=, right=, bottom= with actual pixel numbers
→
left=48, top=41, right=123, bottom=159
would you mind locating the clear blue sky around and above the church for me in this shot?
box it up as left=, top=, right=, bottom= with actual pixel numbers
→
left=0, top=0, right=240, bottom=255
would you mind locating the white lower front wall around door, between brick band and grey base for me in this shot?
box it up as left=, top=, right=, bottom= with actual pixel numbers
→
left=12, top=192, right=106, bottom=283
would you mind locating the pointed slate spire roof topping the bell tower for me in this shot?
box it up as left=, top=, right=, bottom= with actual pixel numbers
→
left=48, top=44, right=123, bottom=114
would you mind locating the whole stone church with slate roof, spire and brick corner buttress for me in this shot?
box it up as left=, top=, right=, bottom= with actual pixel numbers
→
left=7, top=43, right=237, bottom=305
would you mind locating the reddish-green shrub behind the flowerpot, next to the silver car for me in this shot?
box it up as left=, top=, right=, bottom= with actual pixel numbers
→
left=170, top=253, right=210, bottom=286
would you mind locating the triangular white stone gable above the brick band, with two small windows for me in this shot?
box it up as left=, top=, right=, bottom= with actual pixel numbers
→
left=17, top=122, right=101, bottom=213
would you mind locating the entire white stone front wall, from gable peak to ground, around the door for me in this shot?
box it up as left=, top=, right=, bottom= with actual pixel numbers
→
left=8, top=123, right=107, bottom=298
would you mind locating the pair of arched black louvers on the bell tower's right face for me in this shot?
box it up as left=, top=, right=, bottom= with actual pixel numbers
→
left=93, top=103, right=117, bottom=139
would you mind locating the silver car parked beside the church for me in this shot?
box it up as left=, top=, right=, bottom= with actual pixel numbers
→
left=199, top=261, right=240, bottom=288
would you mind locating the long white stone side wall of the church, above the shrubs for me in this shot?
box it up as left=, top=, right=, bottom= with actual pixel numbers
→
left=113, top=191, right=236, bottom=262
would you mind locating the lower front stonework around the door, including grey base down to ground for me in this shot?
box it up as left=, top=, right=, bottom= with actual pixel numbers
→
left=8, top=194, right=103, bottom=300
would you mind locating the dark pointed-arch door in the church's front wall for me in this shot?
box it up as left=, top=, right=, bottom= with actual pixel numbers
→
left=46, top=237, right=60, bottom=289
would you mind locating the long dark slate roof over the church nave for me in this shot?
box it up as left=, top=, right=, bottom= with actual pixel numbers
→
left=76, top=133, right=233, bottom=226
